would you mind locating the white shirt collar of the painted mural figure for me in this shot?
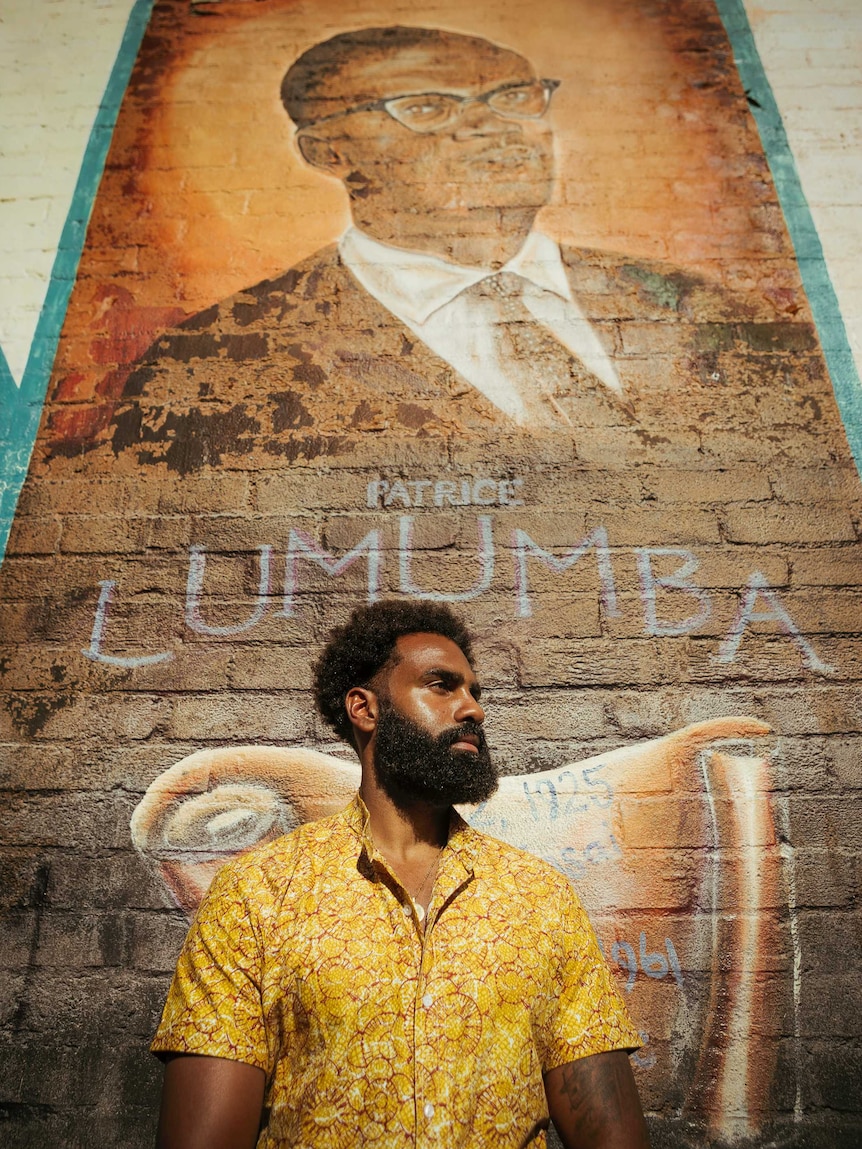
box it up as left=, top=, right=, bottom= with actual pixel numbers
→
left=339, top=228, right=572, bottom=324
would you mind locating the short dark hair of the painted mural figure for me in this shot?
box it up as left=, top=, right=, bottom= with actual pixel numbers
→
left=282, top=24, right=510, bottom=128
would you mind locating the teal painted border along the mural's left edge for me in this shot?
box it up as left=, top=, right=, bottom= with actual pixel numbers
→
left=0, top=0, right=155, bottom=562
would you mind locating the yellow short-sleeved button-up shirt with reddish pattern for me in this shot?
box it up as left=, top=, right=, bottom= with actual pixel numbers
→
left=153, top=796, right=639, bottom=1149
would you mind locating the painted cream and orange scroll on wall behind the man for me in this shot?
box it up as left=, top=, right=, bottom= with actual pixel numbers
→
left=132, top=717, right=798, bottom=1141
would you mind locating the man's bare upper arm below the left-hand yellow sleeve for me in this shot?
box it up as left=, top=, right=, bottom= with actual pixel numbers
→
left=156, top=1054, right=265, bottom=1149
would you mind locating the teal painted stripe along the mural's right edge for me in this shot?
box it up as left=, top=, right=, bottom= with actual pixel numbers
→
left=715, top=0, right=862, bottom=476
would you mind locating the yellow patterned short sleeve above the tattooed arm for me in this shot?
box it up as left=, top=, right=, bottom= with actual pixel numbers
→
left=537, top=886, right=641, bottom=1073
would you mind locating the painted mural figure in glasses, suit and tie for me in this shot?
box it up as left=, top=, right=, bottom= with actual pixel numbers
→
left=102, top=26, right=728, bottom=472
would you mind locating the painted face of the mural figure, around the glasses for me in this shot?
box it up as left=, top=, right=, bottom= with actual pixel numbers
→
left=300, top=38, right=553, bottom=226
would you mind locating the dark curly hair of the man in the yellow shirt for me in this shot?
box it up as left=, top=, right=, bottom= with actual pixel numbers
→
left=314, top=599, right=472, bottom=745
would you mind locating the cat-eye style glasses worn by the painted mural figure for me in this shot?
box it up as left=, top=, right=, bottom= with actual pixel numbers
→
left=306, top=79, right=560, bottom=132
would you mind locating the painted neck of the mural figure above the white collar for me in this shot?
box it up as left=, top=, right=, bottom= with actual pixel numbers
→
left=353, top=203, right=538, bottom=269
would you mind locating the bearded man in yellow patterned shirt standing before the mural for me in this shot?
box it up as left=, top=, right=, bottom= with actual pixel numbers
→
left=153, top=601, right=648, bottom=1149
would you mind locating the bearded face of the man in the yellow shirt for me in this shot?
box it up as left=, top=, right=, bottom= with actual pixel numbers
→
left=374, top=634, right=498, bottom=805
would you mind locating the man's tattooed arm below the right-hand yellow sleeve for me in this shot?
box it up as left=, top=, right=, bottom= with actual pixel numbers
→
left=545, top=1049, right=649, bottom=1149
